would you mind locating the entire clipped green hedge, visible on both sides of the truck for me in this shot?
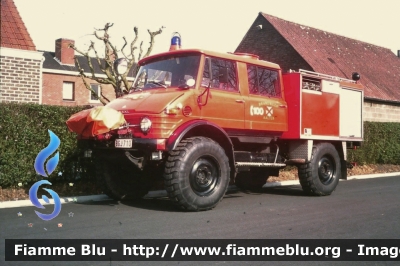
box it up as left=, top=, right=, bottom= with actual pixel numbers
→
left=0, top=103, right=400, bottom=188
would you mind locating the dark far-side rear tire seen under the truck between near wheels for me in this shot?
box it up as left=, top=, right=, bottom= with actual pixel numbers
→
left=235, top=167, right=269, bottom=191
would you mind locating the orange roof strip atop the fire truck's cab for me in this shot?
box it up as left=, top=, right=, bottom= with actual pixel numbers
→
left=139, top=49, right=281, bottom=69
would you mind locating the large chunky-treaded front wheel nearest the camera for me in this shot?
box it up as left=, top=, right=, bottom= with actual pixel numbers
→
left=164, top=137, right=230, bottom=211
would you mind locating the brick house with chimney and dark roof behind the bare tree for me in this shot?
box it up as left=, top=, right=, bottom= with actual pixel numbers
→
left=42, top=38, right=115, bottom=106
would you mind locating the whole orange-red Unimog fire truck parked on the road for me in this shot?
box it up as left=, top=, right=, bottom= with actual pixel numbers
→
left=67, top=40, right=363, bottom=211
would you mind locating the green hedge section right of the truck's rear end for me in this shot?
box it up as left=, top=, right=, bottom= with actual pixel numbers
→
left=348, top=122, right=400, bottom=165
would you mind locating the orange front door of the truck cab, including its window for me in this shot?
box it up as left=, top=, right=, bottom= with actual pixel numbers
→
left=197, top=57, right=244, bottom=129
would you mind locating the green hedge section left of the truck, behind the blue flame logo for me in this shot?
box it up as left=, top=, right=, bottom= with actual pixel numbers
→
left=0, top=103, right=92, bottom=188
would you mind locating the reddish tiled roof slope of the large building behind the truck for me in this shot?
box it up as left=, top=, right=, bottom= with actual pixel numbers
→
left=260, top=13, right=400, bottom=102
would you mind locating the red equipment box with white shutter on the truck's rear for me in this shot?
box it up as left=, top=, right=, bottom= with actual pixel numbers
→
left=282, top=70, right=364, bottom=141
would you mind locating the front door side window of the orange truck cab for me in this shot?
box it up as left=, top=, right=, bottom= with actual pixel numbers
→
left=201, top=57, right=239, bottom=92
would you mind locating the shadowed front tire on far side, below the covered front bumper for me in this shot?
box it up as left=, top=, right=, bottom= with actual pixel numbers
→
left=96, top=156, right=151, bottom=200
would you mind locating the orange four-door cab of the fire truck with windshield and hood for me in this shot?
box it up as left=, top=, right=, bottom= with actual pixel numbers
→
left=107, top=50, right=288, bottom=142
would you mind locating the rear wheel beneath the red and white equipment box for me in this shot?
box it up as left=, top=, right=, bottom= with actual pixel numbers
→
left=298, top=143, right=341, bottom=196
